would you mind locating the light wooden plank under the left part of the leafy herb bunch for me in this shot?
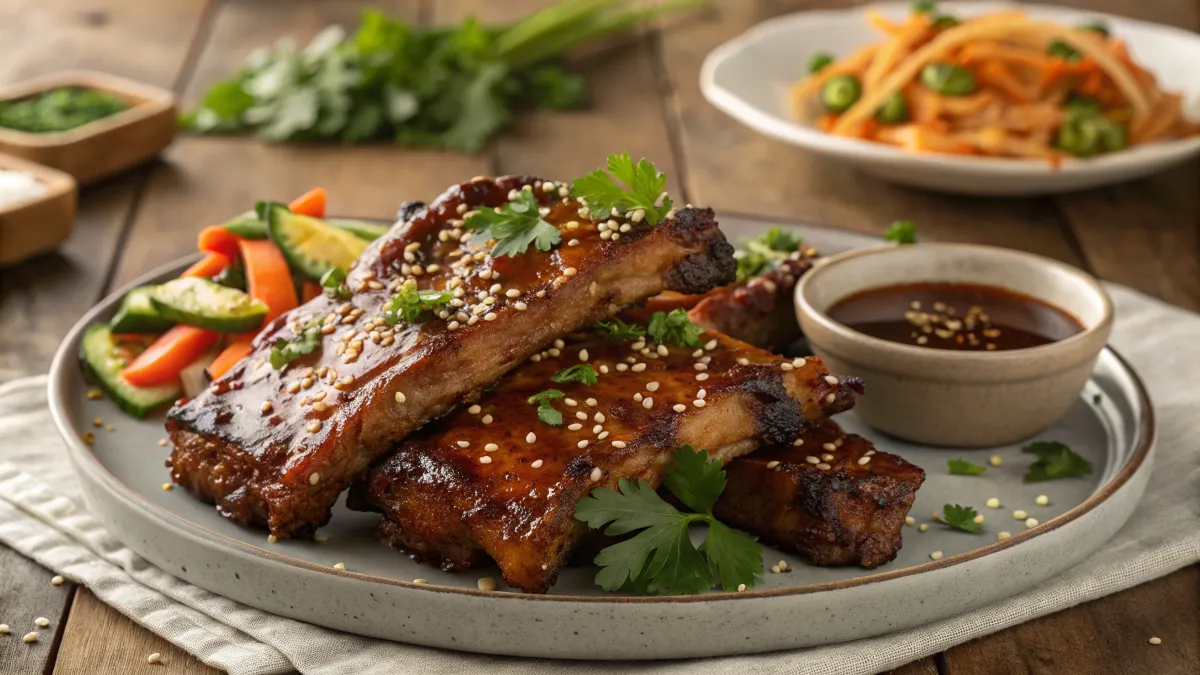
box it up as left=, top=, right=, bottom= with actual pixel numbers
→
left=114, top=0, right=488, bottom=285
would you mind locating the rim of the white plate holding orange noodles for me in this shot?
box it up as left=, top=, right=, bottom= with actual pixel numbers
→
left=700, top=0, right=1200, bottom=178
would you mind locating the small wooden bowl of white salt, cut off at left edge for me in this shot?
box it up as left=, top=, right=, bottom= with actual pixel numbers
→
left=0, top=154, right=77, bottom=265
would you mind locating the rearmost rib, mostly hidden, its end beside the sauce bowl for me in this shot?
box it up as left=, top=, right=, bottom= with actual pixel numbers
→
left=622, top=246, right=817, bottom=352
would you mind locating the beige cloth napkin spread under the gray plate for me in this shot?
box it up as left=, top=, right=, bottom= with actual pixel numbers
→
left=0, top=286, right=1200, bottom=675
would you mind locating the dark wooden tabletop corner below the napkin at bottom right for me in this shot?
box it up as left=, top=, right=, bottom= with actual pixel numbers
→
left=943, top=566, right=1200, bottom=675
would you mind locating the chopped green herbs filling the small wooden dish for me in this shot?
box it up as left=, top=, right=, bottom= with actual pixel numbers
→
left=0, top=86, right=130, bottom=133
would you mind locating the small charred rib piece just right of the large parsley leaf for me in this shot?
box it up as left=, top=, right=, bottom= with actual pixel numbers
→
left=714, top=422, right=925, bottom=568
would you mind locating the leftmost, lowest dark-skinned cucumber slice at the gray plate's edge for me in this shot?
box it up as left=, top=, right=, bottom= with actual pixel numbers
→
left=79, top=323, right=184, bottom=418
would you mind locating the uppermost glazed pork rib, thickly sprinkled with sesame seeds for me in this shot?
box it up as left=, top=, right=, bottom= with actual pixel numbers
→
left=167, top=177, right=734, bottom=537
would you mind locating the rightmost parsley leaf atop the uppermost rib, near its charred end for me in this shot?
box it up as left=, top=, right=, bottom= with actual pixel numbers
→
left=571, top=153, right=673, bottom=225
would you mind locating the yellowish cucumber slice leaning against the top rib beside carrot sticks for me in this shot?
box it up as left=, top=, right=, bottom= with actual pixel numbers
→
left=265, top=204, right=367, bottom=281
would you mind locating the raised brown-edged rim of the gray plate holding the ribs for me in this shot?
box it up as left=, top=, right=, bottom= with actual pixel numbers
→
left=47, top=223, right=1158, bottom=605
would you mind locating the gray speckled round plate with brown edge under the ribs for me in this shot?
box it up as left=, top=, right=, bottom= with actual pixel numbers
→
left=50, top=214, right=1154, bottom=659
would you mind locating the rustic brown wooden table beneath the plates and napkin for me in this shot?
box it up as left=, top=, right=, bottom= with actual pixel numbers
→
left=0, top=0, right=1200, bottom=675
